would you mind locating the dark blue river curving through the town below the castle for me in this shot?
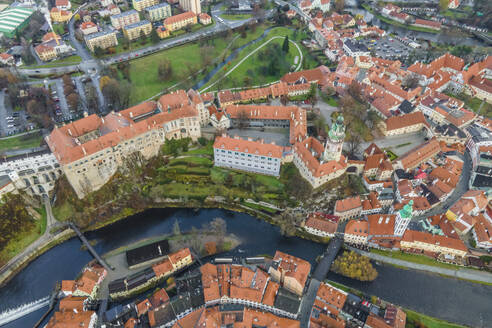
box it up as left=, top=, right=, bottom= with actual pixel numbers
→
left=0, top=209, right=492, bottom=328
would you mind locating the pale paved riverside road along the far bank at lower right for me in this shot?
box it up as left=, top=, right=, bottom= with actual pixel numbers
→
left=349, top=247, right=492, bottom=283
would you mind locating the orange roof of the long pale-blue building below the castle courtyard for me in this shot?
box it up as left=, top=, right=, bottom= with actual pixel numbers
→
left=214, top=136, right=283, bottom=158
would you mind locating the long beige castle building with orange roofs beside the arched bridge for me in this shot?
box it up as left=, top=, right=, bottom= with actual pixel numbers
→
left=46, top=102, right=201, bottom=198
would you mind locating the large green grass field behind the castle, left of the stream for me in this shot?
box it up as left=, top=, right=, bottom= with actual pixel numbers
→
left=120, top=26, right=265, bottom=104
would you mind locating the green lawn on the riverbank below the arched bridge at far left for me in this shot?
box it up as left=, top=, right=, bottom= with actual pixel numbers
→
left=0, top=207, right=46, bottom=264
